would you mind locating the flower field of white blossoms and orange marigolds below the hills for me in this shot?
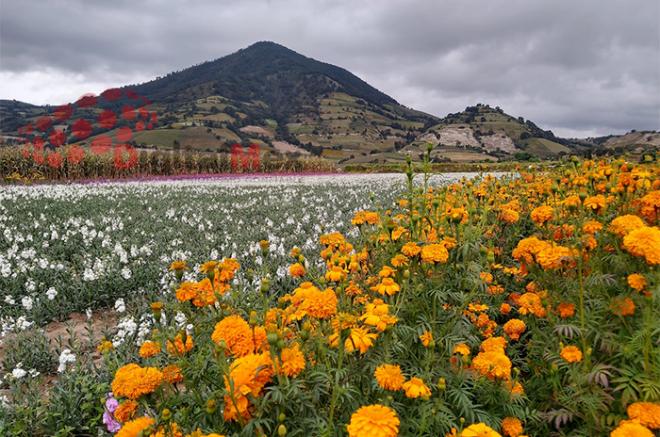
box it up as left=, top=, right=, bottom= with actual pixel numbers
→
left=0, top=161, right=660, bottom=437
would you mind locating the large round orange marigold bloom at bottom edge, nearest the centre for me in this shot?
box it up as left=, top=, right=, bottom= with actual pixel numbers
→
left=346, top=404, right=400, bottom=437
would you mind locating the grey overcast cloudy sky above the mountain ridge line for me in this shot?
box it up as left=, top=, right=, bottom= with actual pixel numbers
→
left=0, top=0, right=660, bottom=136
